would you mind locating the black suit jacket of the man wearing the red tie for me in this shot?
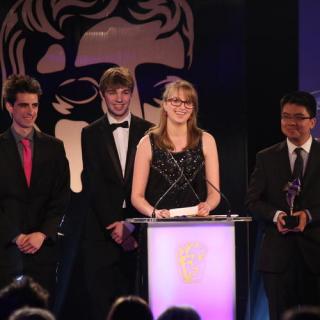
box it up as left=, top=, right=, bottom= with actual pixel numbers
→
left=0, top=129, right=70, bottom=268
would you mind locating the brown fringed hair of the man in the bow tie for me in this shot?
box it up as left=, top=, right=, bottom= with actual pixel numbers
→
left=99, top=67, right=134, bottom=94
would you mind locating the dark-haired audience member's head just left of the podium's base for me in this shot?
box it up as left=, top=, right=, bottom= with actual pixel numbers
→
left=107, top=296, right=153, bottom=320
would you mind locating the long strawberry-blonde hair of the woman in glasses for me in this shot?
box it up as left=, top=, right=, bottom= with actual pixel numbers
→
left=148, top=80, right=202, bottom=151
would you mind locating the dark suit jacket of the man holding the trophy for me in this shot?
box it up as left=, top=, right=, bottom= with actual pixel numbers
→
left=246, top=140, right=320, bottom=274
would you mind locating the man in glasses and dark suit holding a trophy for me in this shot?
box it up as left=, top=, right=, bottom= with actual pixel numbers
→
left=247, top=91, right=320, bottom=320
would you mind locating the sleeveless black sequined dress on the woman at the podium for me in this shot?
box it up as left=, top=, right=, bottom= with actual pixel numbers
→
left=146, top=134, right=207, bottom=209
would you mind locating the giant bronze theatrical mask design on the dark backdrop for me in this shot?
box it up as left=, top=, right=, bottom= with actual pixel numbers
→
left=0, top=0, right=194, bottom=192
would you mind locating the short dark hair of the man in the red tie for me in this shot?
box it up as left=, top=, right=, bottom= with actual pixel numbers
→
left=2, top=74, right=42, bottom=104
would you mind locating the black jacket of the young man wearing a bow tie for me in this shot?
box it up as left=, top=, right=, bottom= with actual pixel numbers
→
left=82, top=115, right=151, bottom=254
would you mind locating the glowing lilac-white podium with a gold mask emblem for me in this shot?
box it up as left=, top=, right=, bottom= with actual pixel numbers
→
left=128, top=215, right=251, bottom=320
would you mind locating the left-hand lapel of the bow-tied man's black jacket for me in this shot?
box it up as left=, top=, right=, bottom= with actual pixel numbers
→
left=100, top=116, right=123, bottom=181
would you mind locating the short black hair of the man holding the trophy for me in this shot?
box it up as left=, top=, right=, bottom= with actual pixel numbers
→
left=280, top=91, right=317, bottom=118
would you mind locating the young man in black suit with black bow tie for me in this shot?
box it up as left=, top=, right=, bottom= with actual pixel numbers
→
left=82, top=67, right=151, bottom=320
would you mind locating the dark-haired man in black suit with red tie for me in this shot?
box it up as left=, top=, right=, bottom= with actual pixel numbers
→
left=0, top=75, right=70, bottom=300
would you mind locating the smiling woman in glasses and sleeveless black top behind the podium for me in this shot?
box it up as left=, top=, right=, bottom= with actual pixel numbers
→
left=131, top=80, right=220, bottom=218
